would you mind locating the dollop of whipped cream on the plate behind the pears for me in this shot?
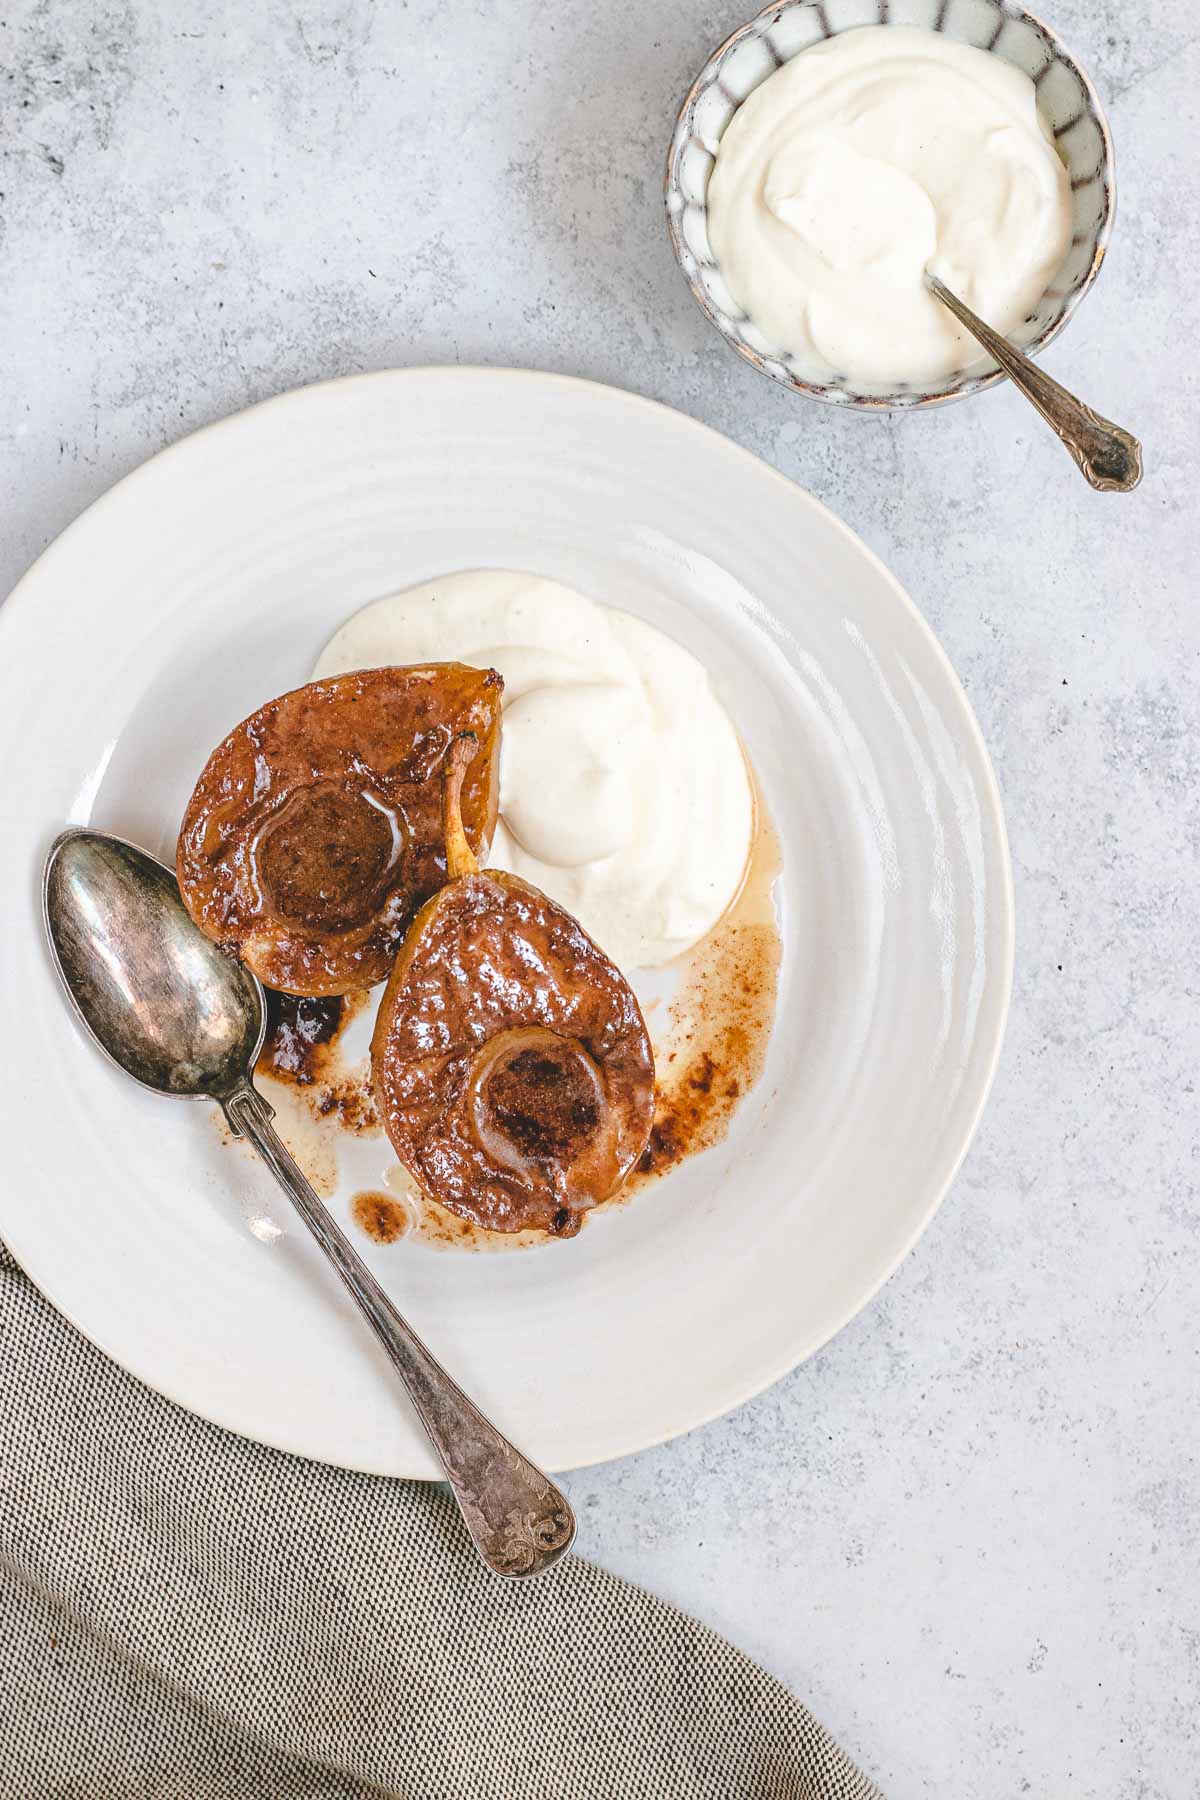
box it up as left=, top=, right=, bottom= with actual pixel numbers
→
left=313, top=569, right=754, bottom=970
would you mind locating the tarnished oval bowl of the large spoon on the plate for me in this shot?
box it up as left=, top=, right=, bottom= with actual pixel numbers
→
left=43, top=830, right=266, bottom=1100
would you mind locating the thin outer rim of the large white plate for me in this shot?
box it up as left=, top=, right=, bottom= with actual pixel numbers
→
left=0, top=364, right=1016, bottom=1481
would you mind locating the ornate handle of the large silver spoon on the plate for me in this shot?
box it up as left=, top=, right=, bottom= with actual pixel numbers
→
left=221, top=1082, right=576, bottom=1577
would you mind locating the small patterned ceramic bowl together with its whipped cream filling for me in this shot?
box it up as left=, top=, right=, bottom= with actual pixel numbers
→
left=667, top=0, right=1114, bottom=409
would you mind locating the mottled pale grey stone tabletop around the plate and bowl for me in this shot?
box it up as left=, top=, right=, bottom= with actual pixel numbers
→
left=0, top=0, right=1200, bottom=1800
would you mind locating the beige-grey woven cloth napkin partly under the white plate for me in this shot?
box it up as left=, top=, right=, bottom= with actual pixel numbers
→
left=0, top=1246, right=880, bottom=1800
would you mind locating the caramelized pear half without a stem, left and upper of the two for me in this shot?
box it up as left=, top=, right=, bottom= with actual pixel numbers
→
left=176, top=662, right=504, bottom=997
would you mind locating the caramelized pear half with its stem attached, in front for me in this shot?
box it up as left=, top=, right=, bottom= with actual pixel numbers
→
left=371, top=738, right=655, bottom=1237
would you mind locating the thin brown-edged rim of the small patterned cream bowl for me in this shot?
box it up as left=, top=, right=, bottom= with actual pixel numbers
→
left=662, top=0, right=1117, bottom=412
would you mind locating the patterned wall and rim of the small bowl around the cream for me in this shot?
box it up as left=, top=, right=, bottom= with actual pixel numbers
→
left=666, top=0, right=1117, bottom=410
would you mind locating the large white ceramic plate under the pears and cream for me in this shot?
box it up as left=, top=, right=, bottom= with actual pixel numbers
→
left=0, top=369, right=1011, bottom=1476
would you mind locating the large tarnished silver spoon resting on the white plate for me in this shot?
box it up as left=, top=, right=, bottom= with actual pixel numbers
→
left=43, top=830, right=576, bottom=1575
